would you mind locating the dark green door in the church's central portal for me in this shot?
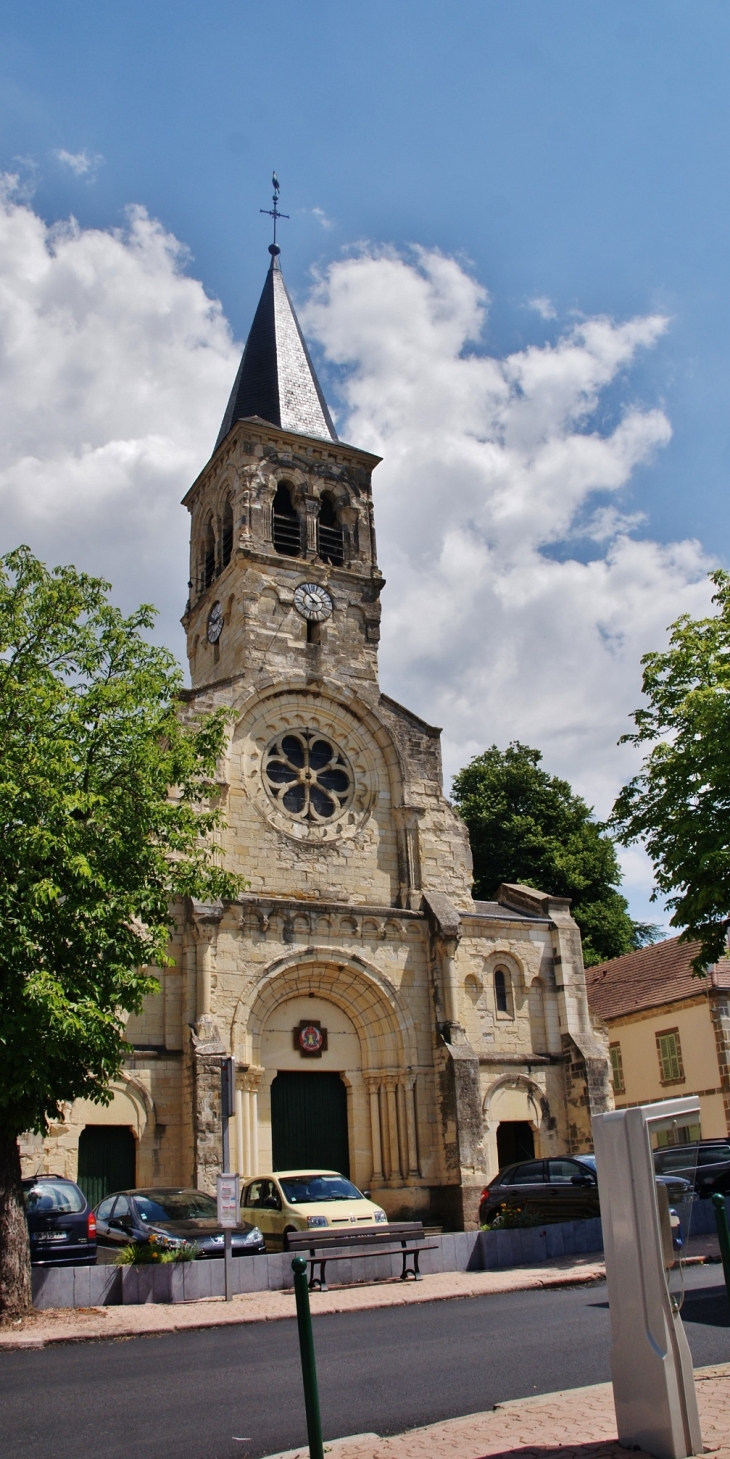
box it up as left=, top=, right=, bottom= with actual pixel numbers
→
left=272, top=1071, right=350, bottom=1176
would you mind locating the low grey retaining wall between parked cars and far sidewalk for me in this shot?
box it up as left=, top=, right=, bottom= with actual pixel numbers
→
left=34, top=1201, right=730, bottom=1307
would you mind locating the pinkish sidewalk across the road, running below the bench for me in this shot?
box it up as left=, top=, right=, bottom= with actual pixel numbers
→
left=0, top=1256, right=606, bottom=1350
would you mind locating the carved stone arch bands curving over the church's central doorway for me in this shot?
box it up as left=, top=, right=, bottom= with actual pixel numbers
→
left=231, top=947, right=416, bottom=1074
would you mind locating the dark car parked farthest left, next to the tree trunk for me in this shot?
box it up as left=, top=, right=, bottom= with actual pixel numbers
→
left=22, top=1176, right=96, bottom=1266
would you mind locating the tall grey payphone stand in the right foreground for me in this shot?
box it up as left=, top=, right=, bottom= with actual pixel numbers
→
left=593, top=1099, right=702, bottom=1459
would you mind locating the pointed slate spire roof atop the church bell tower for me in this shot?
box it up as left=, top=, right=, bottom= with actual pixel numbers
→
left=216, top=244, right=337, bottom=448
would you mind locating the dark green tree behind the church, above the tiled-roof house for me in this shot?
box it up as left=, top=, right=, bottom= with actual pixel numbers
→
left=453, top=741, right=656, bottom=966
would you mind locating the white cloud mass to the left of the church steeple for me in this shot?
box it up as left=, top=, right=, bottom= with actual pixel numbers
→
left=0, top=179, right=238, bottom=657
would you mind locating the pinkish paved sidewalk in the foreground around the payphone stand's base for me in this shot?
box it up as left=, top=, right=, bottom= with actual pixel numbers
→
left=262, top=1363, right=730, bottom=1459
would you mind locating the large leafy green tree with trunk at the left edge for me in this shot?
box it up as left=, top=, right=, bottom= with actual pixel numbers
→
left=0, top=547, right=241, bottom=1316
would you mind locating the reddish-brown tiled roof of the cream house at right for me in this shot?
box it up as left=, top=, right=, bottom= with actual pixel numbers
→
left=585, top=937, right=730, bottom=1018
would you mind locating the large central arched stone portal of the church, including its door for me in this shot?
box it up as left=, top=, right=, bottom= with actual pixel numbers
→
left=232, top=948, right=419, bottom=1186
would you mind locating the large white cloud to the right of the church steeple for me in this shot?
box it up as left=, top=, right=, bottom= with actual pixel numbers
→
left=304, top=249, right=711, bottom=871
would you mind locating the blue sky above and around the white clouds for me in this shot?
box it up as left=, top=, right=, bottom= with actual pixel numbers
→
left=0, top=0, right=730, bottom=912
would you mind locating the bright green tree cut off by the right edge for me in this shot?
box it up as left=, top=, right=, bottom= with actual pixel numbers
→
left=612, top=572, right=730, bottom=973
